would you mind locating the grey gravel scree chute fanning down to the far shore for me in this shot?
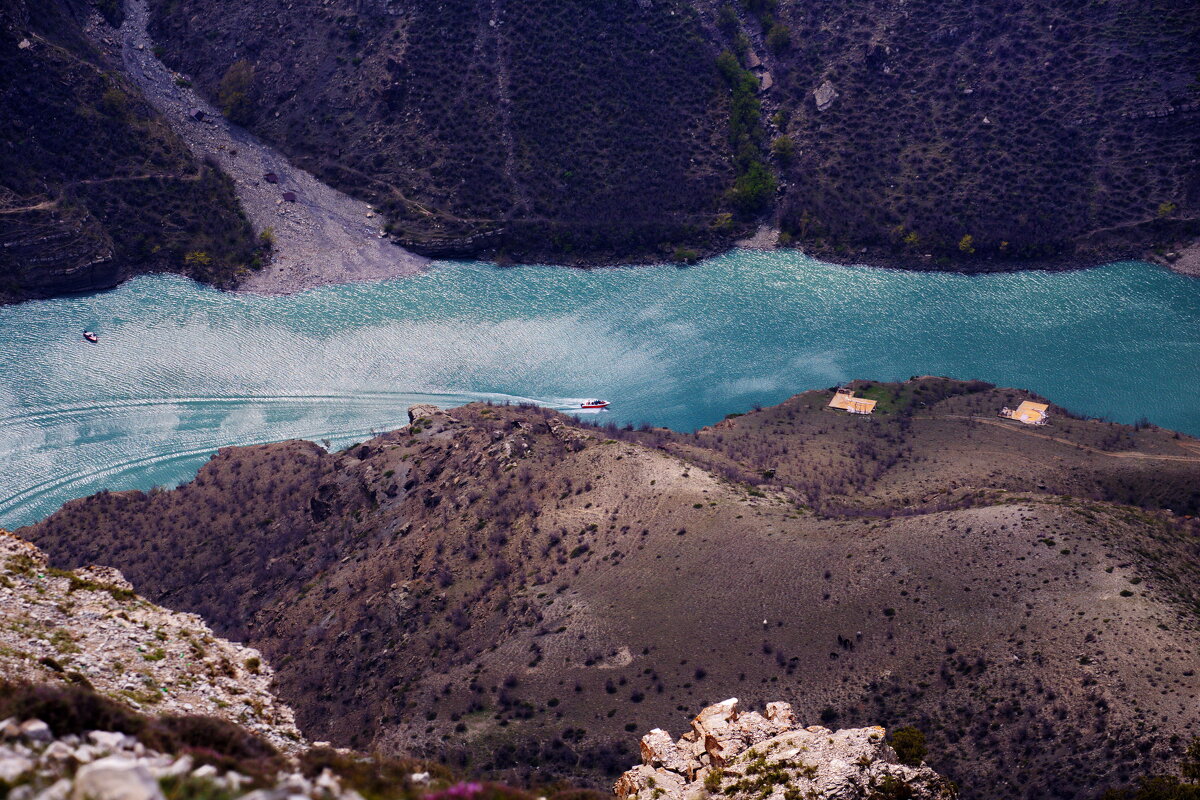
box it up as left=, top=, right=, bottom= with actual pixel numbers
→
left=90, top=0, right=428, bottom=294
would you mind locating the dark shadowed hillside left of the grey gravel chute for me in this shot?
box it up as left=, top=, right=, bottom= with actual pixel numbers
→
left=0, top=0, right=260, bottom=302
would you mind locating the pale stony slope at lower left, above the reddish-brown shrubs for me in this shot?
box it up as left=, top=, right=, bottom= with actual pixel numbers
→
left=0, top=530, right=304, bottom=751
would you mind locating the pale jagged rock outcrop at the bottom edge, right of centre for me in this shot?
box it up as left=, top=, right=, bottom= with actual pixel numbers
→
left=613, top=698, right=956, bottom=800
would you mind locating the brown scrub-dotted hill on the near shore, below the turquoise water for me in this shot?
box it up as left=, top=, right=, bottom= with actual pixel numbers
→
left=20, top=378, right=1200, bottom=798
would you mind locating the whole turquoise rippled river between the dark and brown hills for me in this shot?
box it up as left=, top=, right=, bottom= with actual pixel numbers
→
left=0, top=251, right=1200, bottom=527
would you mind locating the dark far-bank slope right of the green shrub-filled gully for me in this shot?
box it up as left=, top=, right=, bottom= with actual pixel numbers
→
left=745, top=0, right=1200, bottom=269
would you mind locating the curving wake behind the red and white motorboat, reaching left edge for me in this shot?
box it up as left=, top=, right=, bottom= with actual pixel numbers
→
left=0, top=391, right=566, bottom=528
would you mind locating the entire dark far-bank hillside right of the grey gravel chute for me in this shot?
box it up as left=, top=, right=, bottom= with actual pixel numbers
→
left=142, top=0, right=1200, bottom=270
